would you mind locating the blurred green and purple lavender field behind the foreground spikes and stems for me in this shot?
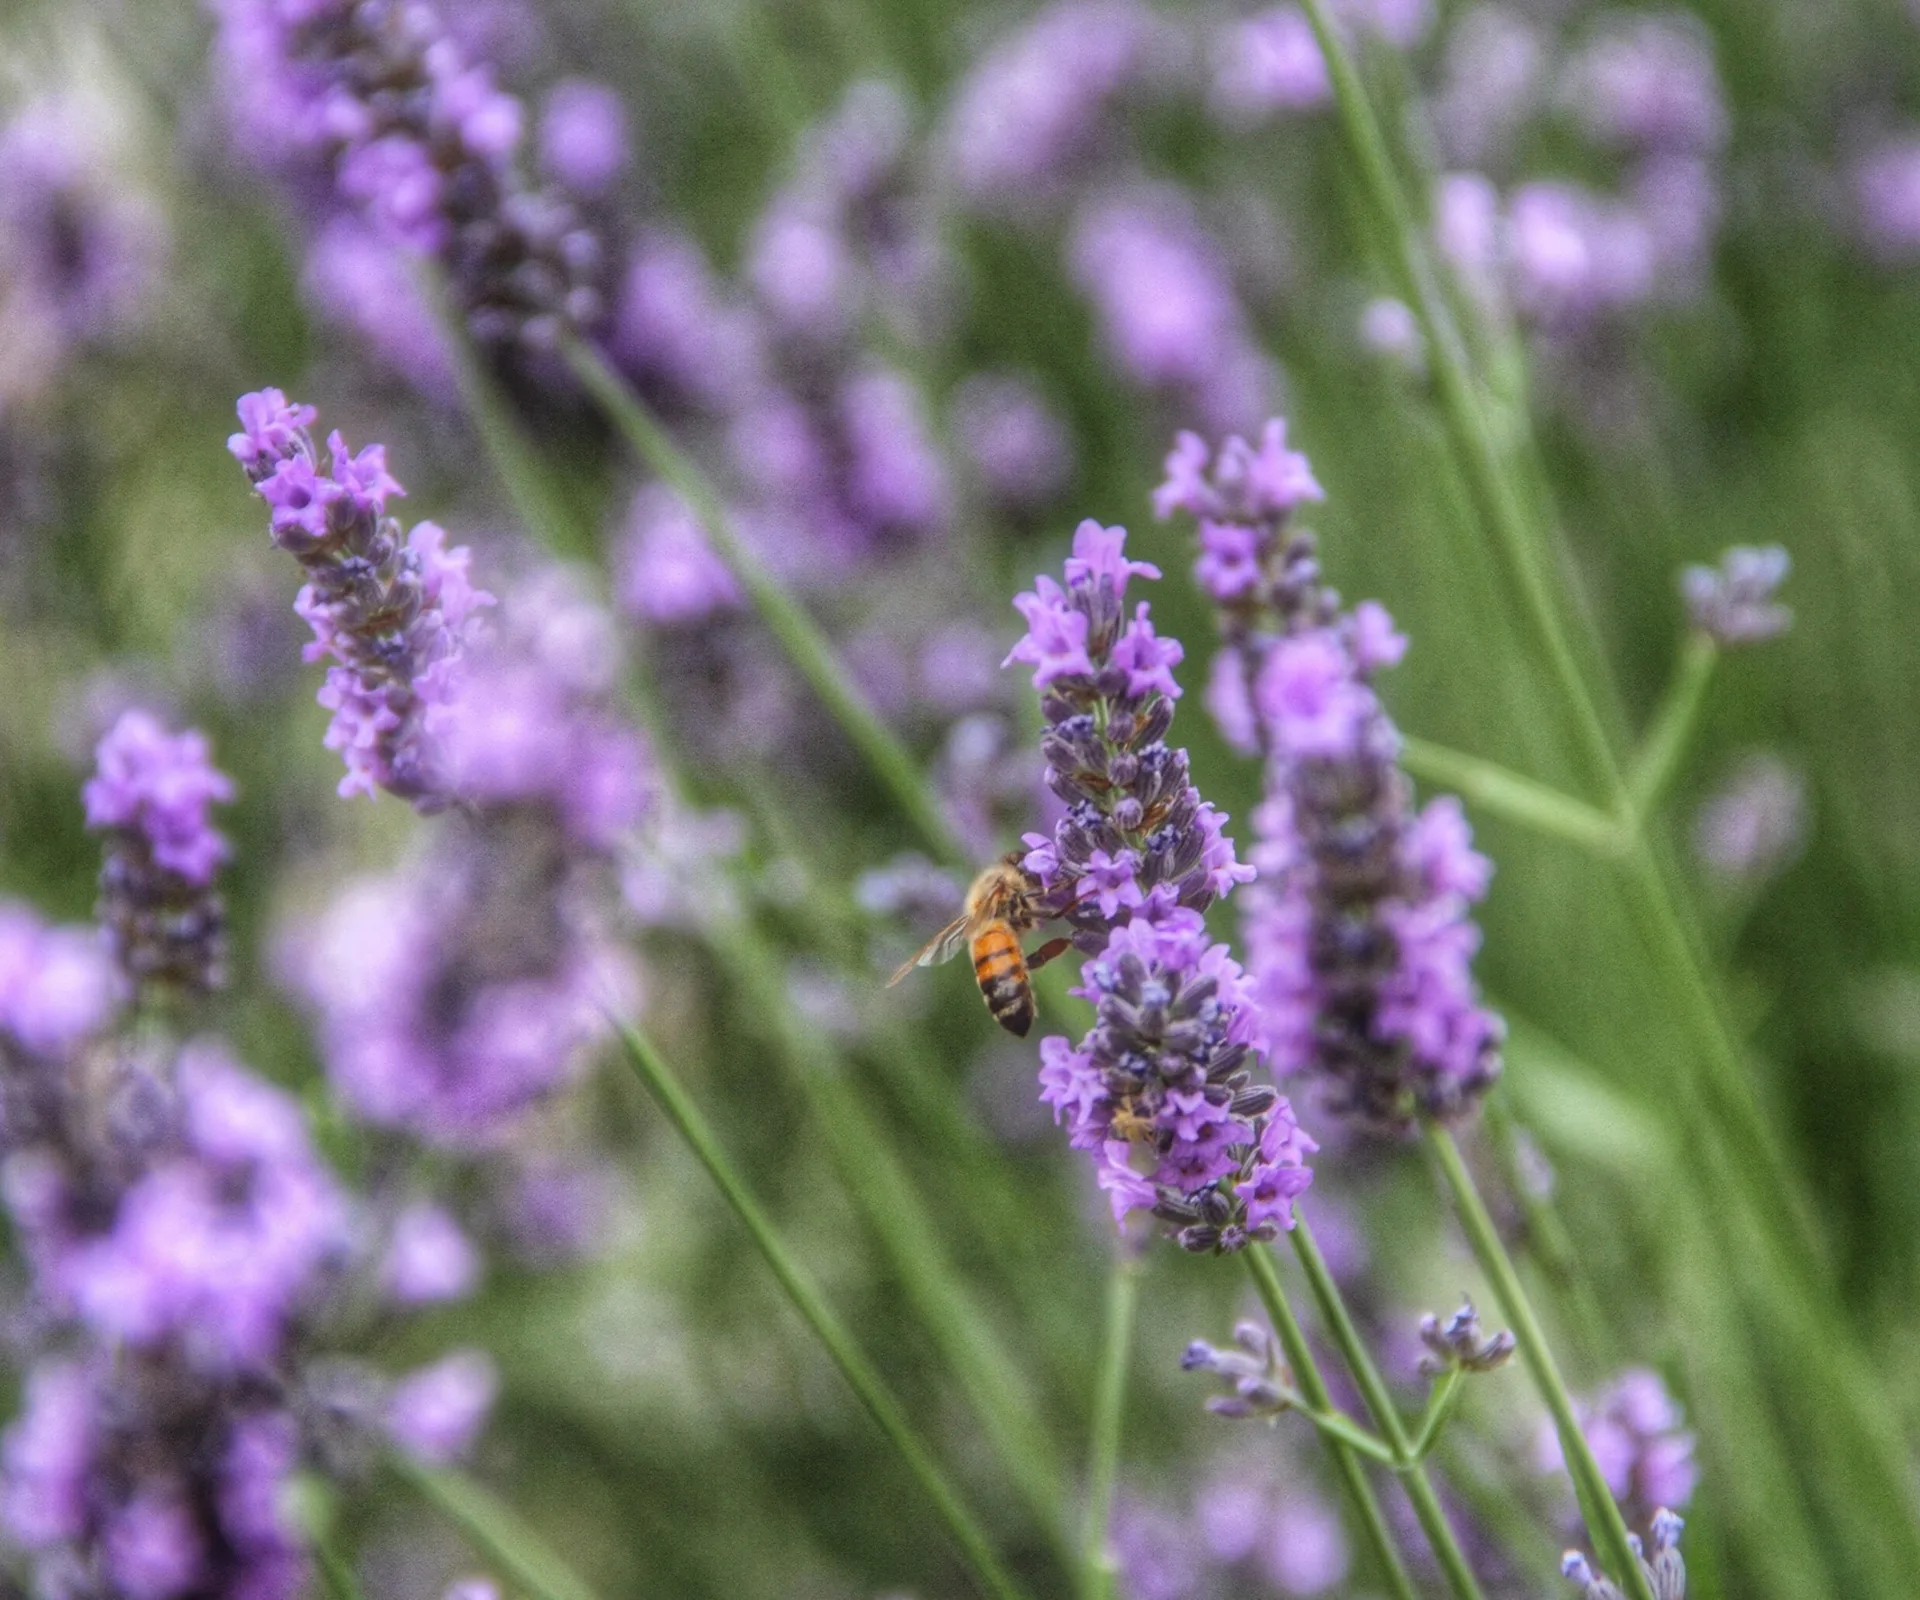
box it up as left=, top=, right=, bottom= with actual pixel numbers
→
left=0, top=0, right=1920, bottom=1600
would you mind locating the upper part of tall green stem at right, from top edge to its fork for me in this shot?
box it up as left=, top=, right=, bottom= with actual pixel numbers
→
left=1306, top=0, right=1620, bottom=801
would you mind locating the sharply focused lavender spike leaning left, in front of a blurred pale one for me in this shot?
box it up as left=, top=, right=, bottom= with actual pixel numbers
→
left=227, top=388, right=493, bottom=811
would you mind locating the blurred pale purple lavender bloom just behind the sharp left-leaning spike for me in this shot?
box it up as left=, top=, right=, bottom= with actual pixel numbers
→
left=282, top=569, right=651, bottom=1147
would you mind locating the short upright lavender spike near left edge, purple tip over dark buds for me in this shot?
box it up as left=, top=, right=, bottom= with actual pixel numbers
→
left=81, top=711, right=234, bottom=993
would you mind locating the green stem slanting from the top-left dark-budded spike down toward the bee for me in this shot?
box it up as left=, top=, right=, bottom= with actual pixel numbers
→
left=564, top=330, right=968, bottom=864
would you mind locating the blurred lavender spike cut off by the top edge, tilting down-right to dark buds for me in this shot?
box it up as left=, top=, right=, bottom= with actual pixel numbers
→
left=213, top=0, right=605, bottom=352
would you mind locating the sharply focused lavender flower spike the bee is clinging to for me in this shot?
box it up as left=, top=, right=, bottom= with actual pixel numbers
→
left=1008, top=521, right=1317, bottom=1252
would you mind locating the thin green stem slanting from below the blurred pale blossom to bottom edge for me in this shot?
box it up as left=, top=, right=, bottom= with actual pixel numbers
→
left=620, top=1024, right=1025, bottom=1600
